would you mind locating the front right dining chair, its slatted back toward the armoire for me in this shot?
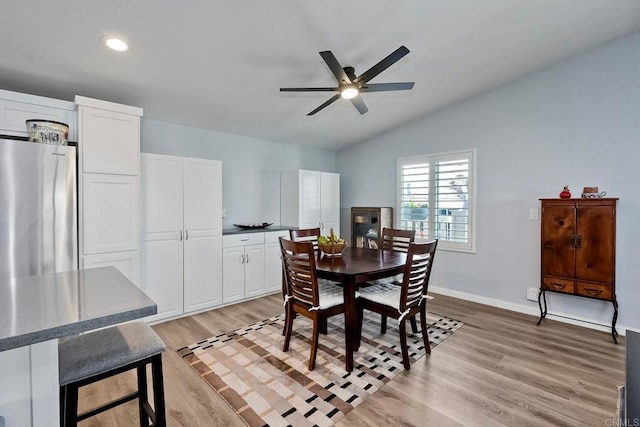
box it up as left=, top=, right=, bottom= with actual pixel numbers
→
left=358, top=240, right=438, bottom=370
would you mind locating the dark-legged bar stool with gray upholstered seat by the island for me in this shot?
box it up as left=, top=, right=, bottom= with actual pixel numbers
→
left=58, top=322, right=166, bottom=427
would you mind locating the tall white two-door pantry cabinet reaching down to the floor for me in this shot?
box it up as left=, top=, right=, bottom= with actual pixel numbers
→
left=142, top=154, right=222, bottom=320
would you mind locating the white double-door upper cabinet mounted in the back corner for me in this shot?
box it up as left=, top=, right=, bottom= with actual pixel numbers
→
left=280, top=169, right=340, bottom=235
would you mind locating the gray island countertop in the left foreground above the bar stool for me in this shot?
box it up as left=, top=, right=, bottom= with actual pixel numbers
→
left=0, top=267, right=158, bottom=351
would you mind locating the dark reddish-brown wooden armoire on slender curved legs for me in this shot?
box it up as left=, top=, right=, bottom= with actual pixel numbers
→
left=538, top=198, right=618, bottom=343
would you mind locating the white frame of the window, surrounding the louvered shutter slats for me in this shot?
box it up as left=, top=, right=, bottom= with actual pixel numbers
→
left=394, top=148, right=477, bottom=254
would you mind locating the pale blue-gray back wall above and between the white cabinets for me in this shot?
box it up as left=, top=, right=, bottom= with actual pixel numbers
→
left=141, top=118, right=335, bottom=227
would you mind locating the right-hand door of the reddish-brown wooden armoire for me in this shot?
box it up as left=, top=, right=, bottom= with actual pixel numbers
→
left=576, top=206, right=615, bottom=283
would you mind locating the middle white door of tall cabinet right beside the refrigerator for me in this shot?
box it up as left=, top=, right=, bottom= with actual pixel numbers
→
left=82, top=174, right=140, bottom=254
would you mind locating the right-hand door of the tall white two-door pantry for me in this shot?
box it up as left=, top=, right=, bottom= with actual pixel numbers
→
left=184, top=158, right=222, bottom=312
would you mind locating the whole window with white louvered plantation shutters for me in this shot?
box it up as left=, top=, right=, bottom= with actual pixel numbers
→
left=395, top=150, right=475, bottom=252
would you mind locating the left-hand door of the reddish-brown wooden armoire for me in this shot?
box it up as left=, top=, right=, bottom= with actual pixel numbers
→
left=541, top=205, right=576, bottom=277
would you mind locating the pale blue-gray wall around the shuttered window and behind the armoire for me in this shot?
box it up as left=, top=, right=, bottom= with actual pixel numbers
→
left=336, top=33, right=640, bottom=329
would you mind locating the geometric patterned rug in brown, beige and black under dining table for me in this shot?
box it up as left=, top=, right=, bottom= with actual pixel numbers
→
left=178, top=311, right=462, bottom=427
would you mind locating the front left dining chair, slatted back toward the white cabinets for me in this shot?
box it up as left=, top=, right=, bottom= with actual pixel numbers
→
left=280, top=237, right=344, bottom=371
